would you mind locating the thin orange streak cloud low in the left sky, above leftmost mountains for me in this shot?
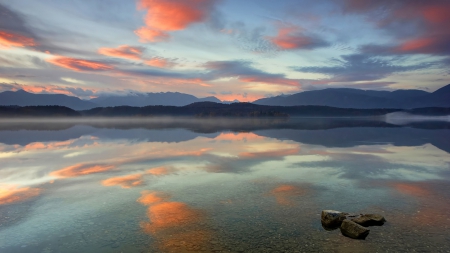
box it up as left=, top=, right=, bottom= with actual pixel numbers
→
left=46, top=56, right=114, bottom=71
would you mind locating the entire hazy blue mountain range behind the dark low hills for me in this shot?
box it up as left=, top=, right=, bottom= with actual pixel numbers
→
left=0, top=84, right=450, bottom=110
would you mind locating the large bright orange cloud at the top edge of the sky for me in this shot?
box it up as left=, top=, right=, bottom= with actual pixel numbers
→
left=135, top=0, right=217, bottom=42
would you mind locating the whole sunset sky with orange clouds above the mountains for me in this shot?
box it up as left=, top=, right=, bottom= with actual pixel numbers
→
left=0, top=0, right=450, bottom=101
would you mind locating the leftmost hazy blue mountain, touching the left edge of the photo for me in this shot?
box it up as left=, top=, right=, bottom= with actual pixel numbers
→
left=0, top=90, right=98, bottom=110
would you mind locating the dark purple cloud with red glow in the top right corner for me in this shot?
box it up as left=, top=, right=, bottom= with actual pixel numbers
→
left=341, top=0, right=450, bottom=55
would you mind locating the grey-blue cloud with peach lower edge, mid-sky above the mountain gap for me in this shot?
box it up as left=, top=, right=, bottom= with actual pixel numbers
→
left=203, top=61, right=300, bottom=87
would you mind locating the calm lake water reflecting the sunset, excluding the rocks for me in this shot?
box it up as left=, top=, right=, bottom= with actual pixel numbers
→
left=0, top=118, right=450, bottom=253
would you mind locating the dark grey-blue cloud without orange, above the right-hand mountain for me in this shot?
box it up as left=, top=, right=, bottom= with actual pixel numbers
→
left=293, top=54, right=430, bottom=82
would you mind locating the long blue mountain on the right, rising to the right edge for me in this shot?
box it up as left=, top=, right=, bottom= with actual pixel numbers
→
left=253, top=84, right=450, bottom=109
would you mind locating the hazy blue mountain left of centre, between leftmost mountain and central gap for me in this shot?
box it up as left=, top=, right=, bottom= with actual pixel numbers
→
left=90, top=92, right=221, bottom=107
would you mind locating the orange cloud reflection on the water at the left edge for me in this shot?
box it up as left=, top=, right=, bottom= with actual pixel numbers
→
left=0, top=185, right=41, bottom=205
